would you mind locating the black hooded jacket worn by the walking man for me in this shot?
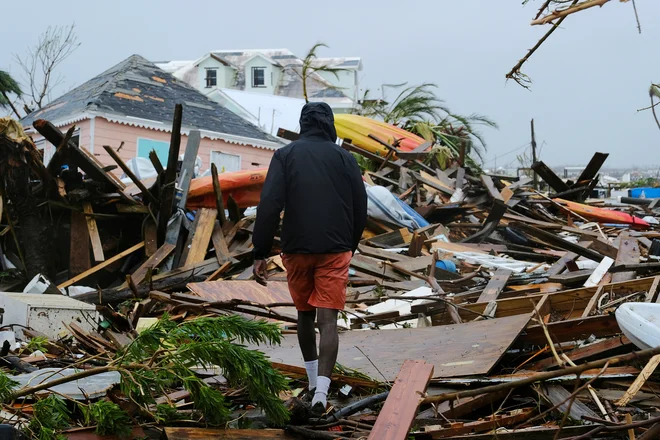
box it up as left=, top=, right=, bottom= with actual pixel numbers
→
left=252, top=102, right=367, bottom=259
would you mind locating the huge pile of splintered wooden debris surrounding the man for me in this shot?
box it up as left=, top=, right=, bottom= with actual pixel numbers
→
left=0, top=109, right=660, bottom=440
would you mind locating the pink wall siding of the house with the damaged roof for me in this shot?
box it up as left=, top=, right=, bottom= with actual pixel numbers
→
left=34, top=116, right=275, bottom=175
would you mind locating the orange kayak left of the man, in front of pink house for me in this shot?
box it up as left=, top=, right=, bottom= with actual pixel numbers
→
left=186, top=168, right=268, bottom=209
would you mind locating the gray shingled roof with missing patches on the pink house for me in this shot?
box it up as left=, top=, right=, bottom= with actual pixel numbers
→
left=21, top=55, right=281, bottom=144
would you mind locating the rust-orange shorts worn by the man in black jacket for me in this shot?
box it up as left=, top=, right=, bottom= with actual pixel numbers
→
left=282, top=251, right=353, bottom=312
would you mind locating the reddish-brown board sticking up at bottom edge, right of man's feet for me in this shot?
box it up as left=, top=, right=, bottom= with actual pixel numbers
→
left=368, top=360, right=433, bottom=440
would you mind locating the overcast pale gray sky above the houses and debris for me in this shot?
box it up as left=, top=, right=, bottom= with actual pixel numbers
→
left=0, top=0, right=660, bottom=167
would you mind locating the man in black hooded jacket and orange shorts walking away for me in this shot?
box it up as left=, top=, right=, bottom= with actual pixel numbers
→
left=252, top=102, right=367, bottom=416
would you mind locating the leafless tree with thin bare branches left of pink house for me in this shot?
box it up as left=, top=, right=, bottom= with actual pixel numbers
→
left=14, top=23, right=80, bottom=108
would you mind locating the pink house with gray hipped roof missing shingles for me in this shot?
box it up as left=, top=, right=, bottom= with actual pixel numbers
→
left=21, top=55, right=282, bottom=174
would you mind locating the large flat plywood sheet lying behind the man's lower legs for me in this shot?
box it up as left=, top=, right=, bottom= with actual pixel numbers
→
left=254, top=314, right=530, bottom=381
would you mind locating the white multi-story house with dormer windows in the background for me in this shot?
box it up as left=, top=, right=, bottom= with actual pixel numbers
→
left=156, top=49, right=362, bottom=114
